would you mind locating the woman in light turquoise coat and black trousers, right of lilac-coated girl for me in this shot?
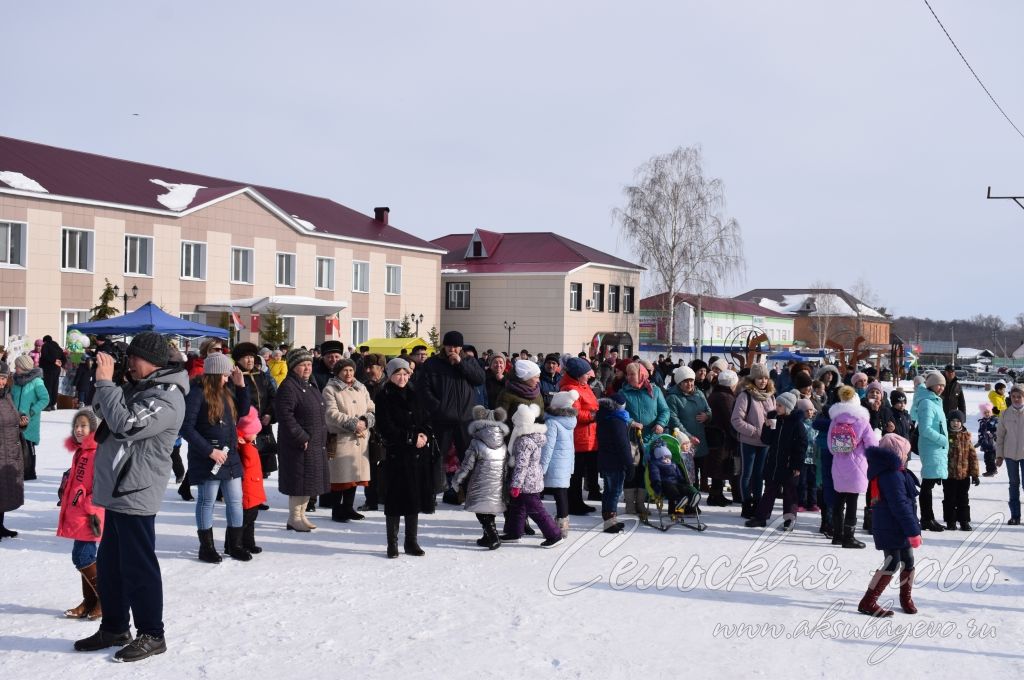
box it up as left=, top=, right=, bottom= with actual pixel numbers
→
left=913, top=372, right=949, bottom=532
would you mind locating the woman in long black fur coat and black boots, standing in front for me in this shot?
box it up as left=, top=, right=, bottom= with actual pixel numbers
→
left=374, top=358, right=437, bottom=557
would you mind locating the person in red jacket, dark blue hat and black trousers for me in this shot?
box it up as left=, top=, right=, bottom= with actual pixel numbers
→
left=558, top=356, right=601, bottom=515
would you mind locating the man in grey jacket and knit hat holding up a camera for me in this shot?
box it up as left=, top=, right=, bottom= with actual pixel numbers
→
left=75, top=331, right=188, bottom=662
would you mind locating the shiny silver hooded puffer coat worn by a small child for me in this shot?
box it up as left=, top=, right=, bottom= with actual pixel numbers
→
left=452, top=418, right=509, bottom=515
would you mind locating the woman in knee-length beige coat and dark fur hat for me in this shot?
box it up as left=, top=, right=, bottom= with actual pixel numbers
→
left=324, top=358, right=375, bottom=522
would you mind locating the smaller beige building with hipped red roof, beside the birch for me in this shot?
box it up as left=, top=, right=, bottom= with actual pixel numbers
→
left=433, top=229, right=643, bottom=355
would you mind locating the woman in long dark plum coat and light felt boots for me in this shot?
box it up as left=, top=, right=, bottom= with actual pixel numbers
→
left=273, top=348, right=331, bottom=532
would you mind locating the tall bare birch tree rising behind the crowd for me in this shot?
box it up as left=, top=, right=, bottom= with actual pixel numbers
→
left=612, top=146, right=745, bottom=351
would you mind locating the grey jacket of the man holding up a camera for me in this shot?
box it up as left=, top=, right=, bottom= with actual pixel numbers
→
left=92, top=367, right=190, bottom=515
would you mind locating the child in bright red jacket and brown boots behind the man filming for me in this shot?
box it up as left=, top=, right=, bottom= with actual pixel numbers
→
left=57, top=409, right=103, bottom=621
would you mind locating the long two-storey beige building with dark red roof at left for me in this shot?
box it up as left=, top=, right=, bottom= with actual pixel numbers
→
left=0, top=137, right=442, bottom=345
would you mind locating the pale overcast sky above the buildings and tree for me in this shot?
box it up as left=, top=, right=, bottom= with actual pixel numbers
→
left=8, top=0, right=1024, bottom=321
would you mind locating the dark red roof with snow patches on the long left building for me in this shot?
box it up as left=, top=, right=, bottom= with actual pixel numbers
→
left=0, top=136, right=437, bottom=250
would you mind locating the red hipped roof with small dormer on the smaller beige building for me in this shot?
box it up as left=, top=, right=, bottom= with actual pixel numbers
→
left=431, top=229, right=643, bottom=273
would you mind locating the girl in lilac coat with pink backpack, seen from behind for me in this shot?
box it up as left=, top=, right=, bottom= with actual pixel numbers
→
left=825, top=385, right=879, bottom=548
